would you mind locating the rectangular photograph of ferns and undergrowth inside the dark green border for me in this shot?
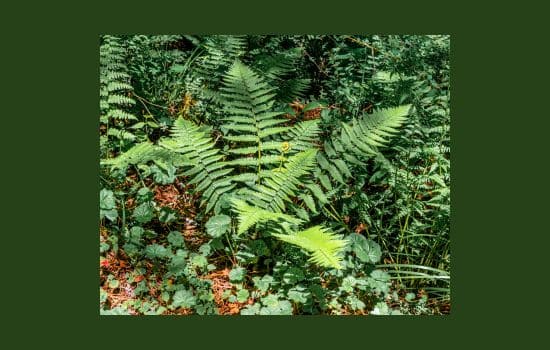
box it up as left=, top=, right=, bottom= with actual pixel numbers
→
left=99, top=35, right=450, bottom=315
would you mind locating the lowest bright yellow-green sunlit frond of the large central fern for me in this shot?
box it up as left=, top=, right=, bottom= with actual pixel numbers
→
left=273, top=226, right=347, bottom=269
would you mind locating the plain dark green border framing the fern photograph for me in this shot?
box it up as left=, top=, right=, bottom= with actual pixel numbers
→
left=2, top=1, right=548, bottom=349
